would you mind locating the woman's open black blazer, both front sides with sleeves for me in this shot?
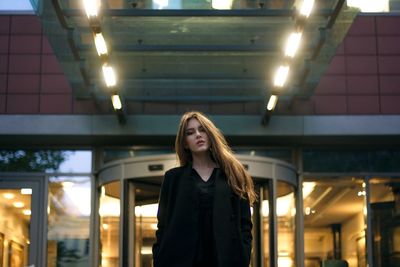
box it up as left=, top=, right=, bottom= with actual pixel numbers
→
left=153, top=165, right=252, bottom=267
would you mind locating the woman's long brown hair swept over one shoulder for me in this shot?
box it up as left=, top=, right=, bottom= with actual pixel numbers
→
left=175, top=111, right=257, bottom=204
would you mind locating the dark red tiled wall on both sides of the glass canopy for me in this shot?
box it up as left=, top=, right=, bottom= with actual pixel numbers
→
left=0, top=15, right=400, bottom=115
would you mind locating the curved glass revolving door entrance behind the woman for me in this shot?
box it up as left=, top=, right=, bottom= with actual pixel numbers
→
left=98, top=155, right=299, bottom=267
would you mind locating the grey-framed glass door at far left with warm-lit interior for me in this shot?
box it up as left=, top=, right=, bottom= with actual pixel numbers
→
left=0, top=174, right=46, bottom=267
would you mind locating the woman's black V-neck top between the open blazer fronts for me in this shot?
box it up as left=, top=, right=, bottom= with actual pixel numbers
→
left=192, top=169, right=217, bottom=267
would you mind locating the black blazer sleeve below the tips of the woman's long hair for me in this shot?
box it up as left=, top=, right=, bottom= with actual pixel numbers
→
left=240, top=199, right=253, bottom=265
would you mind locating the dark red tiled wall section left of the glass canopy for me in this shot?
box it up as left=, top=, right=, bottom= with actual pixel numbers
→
left=0, top=15, right=99, bottom=114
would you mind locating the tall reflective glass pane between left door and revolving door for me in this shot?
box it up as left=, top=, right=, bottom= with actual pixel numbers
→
left=47, top=176, right=91, bottom=267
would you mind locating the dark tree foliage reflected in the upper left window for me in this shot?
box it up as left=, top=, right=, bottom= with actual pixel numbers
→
left=0, top=150, right=67, bottom=172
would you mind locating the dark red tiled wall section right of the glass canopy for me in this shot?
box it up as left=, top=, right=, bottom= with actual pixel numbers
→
left=286, top=16, right=400, bottom=115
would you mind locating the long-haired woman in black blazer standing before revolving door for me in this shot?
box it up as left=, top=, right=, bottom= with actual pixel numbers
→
left=153, top=111, right=256, bottom=267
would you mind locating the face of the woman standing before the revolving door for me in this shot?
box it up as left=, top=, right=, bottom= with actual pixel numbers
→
left=185, top=118, right=210, bottom=153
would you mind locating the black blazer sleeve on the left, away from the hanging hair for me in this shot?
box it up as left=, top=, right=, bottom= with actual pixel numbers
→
left=152, top=172, right=170, bottom=258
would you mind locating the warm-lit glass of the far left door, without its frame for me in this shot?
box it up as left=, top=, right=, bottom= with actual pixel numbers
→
left=0, top=189, right=31, bottom=266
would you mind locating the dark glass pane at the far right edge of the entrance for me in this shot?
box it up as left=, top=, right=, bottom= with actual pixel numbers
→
left=370, top=178, right=400, bottom=267
